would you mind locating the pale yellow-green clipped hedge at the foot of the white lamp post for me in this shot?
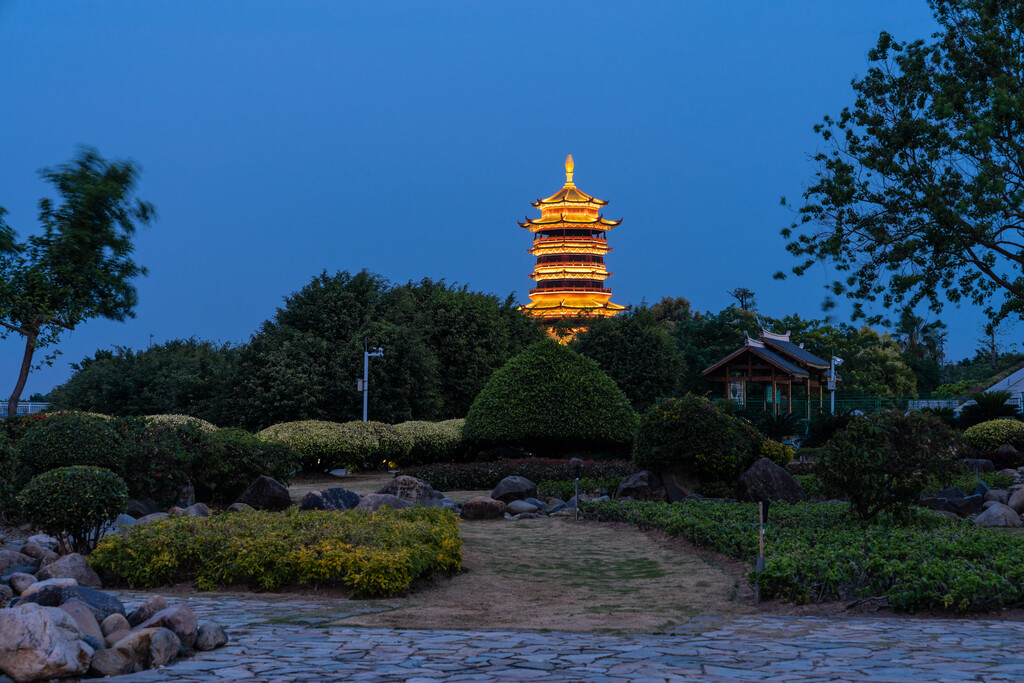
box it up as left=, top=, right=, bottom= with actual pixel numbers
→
left=257, top=420, right=413, bottom=470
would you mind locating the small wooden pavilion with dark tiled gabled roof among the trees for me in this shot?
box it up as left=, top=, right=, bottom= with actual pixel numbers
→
left=701, top=330, right=839, bottom=419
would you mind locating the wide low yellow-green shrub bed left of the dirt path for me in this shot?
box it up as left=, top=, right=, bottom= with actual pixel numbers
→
left=89, top=507, right=462, bottom=597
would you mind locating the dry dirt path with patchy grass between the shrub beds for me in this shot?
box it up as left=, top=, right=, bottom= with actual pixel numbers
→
left=338, top=518, right=753, bottom=633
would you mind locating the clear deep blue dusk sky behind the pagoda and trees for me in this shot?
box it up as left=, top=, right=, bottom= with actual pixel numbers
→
left=0, top=0, right=982, bottom=397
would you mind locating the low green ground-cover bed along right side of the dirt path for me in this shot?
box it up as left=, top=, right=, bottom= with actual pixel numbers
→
left=582, top=501, right=1024, bottom=612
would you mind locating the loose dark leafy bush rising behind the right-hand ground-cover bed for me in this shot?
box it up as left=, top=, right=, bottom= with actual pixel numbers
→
left=814, top=411, right=965, bottom=520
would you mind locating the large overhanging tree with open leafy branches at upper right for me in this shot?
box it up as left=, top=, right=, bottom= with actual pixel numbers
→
left=776, top=0, right=1024, bottom=322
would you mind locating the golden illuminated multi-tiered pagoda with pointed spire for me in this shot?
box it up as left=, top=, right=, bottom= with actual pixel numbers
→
left=519, top=155, right=627, bottom=329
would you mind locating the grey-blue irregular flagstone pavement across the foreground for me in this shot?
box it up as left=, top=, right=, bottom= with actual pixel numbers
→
left=108, top=593, right=1024, bottom=683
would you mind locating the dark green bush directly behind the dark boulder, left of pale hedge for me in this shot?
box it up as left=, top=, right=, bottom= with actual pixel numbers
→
left=193, top=429, right=302, bottom=504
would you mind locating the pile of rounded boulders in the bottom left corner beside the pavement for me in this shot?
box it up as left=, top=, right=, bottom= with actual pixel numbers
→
left=0, top=535, right=227, bottom=683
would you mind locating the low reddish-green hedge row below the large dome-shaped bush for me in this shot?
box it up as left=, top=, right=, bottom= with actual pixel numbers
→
left=398, top=458, right=636, bottom=490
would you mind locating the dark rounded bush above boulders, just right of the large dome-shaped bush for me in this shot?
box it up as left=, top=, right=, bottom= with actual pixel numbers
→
left=633, top=394, right=762, bottom=483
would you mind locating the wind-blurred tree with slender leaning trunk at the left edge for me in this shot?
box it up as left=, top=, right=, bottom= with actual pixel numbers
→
left=0, top=148, right=155, bottom=415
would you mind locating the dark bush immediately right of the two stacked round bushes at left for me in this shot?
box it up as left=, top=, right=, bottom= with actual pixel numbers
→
left=112, top=418, right=206, bottom=508
